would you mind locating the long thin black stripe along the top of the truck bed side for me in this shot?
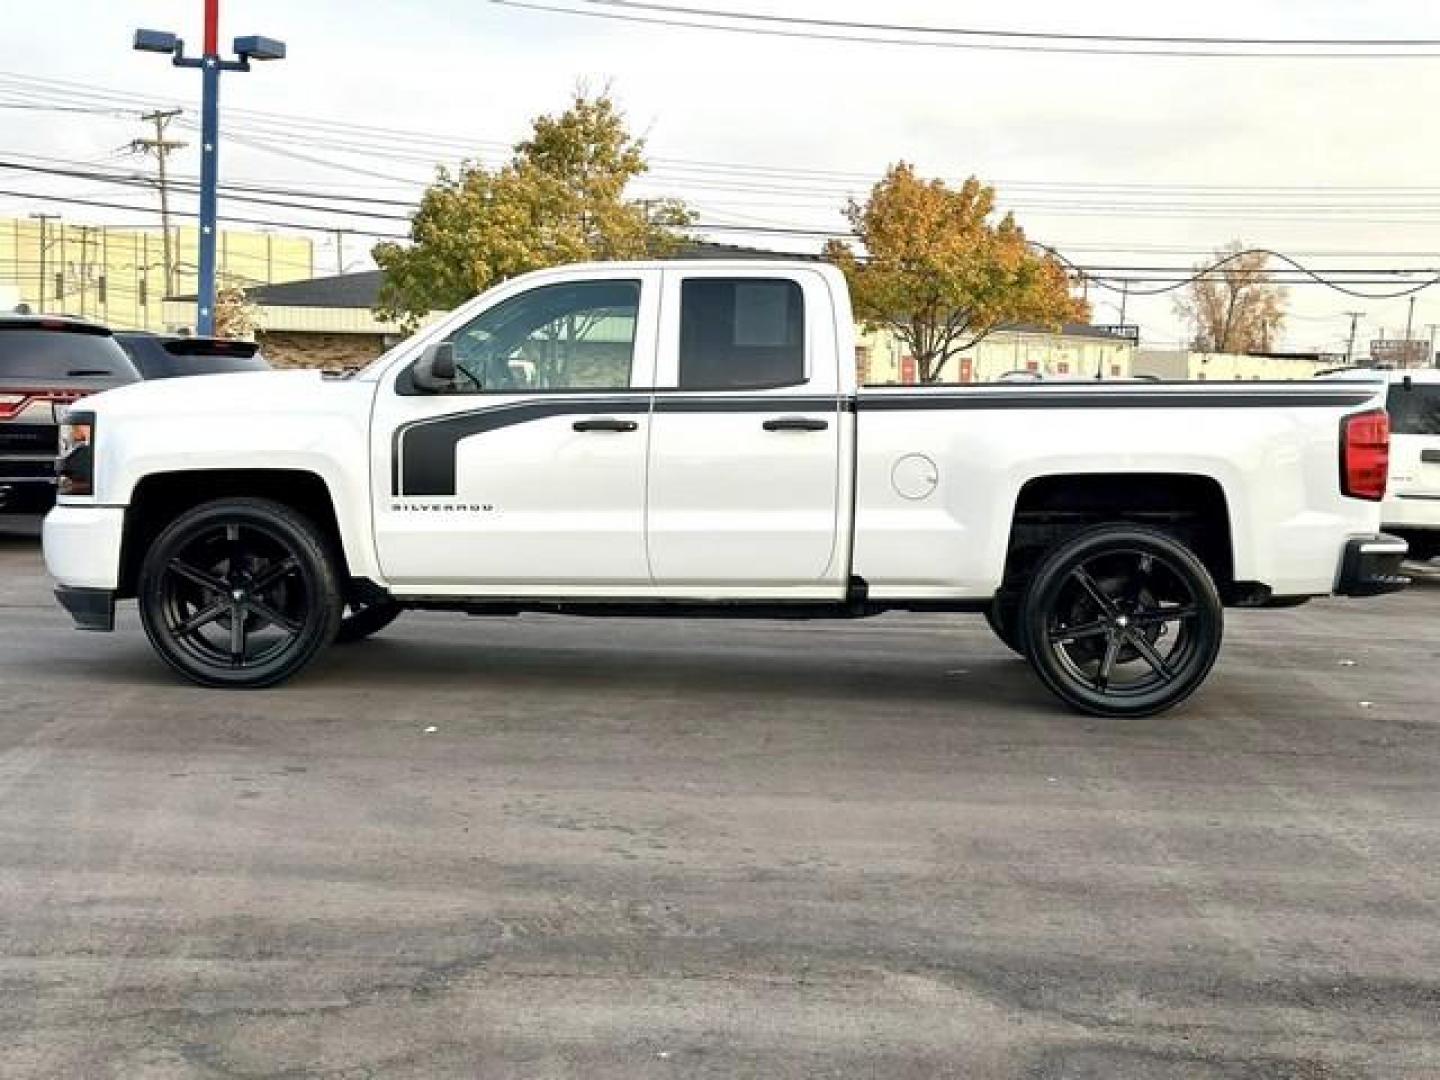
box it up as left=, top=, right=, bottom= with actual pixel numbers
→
left=857, top=390, right=1375, bottom=412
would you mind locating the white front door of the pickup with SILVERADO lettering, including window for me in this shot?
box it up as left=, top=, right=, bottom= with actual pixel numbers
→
left=372, top=268, right=661, bottom=595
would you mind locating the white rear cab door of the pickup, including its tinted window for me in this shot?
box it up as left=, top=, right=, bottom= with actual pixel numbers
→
left=645, top=266, right=854, bottom=598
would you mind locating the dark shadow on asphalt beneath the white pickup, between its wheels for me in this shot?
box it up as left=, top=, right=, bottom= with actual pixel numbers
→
left=68, top=619, right=1060, bottom=711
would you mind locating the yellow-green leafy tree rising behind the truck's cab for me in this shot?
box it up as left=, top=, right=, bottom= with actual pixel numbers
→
left=374, top=92, right=691, bottom=324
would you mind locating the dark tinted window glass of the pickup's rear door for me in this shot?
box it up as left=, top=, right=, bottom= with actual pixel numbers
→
left=677, top=278, right=806, bottom=390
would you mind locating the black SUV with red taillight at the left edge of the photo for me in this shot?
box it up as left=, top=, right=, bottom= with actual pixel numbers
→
left=0, top=315, right=140, bottom=514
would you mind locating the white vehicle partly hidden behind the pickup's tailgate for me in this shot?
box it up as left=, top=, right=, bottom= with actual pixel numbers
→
left=1322, top=367, right=1440, bottom=560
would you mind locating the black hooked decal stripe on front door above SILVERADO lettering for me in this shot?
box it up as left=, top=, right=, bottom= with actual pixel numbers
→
left=390, top=397, right=649, bottom=497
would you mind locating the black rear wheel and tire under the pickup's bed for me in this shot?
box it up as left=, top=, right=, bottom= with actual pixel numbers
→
left=1021, top=526, right=1224, bottom=717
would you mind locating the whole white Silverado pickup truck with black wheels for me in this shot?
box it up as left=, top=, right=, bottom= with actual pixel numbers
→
left=45, top=261, right=1405, bottom=716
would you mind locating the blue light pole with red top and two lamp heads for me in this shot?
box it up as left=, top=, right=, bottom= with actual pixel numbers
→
left=135, top=0, right=285, bottom=336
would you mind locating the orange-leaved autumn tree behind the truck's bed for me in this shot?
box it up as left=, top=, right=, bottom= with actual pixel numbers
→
left=825, top=161, right=1090, bottom=383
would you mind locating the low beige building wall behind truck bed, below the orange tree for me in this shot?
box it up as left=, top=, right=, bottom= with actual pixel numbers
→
left=857, top=328, right=1136, bottom=386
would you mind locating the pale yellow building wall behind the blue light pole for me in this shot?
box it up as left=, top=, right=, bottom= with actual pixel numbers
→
left=0, top=217, right=314, bottom=331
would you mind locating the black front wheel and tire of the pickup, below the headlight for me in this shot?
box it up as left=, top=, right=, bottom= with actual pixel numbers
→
left=137, top=498, right=344, bottom=690
